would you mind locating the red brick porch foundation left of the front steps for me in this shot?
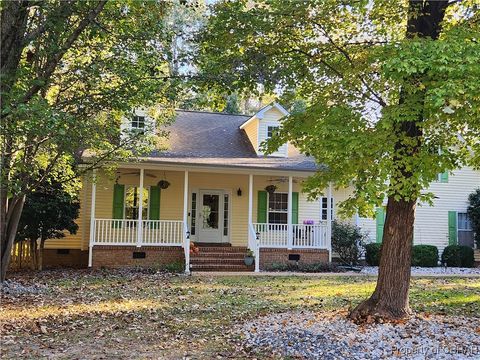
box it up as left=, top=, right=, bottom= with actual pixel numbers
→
left=92, top=246, right=185, bottom=268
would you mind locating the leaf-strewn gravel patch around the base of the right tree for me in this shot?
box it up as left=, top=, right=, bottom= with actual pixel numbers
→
left=240, top=312, right=480, bottom=360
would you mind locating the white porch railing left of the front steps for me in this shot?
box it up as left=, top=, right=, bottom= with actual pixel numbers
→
left=92, top=219, right=184, bottom=246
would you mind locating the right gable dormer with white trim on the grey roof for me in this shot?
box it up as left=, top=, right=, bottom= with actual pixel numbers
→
left=240, top=103, right=289, bottom=157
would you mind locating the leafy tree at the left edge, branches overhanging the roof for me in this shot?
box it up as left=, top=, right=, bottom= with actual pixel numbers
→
left=0, top=0, right=180, bottom=281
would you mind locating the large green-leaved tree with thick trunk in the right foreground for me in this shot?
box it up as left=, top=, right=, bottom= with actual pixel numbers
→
left=199, top=0, right=480, bottom=321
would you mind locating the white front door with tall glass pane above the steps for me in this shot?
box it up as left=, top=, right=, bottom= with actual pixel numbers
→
left=198, top=190, right=223, bottom=243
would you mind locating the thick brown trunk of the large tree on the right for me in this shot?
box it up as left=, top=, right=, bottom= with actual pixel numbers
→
left=350, top=0, right=449, bottom=321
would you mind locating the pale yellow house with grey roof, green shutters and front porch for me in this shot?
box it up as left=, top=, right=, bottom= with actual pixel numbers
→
left=45, top=103, right=480, bottom=271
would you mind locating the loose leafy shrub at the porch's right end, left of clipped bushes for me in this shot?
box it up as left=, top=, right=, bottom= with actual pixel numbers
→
left=332, top=221, right=366, bottom=265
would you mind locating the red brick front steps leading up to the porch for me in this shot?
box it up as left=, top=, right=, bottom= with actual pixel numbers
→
left=190, top=244, right=254, bottom=272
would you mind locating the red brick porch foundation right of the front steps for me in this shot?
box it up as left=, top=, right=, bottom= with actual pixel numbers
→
left=260, top=248, right=328, bottom=270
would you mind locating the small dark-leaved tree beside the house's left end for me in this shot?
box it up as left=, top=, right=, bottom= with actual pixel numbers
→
left=17, top=181, right=80, bottom=270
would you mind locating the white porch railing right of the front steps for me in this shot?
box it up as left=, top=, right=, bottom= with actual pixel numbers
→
left=253, top=223, right=328, bottom=249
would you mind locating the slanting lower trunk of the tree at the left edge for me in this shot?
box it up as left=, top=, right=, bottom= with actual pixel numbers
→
left=0, top=195, right=25, bottom=282
